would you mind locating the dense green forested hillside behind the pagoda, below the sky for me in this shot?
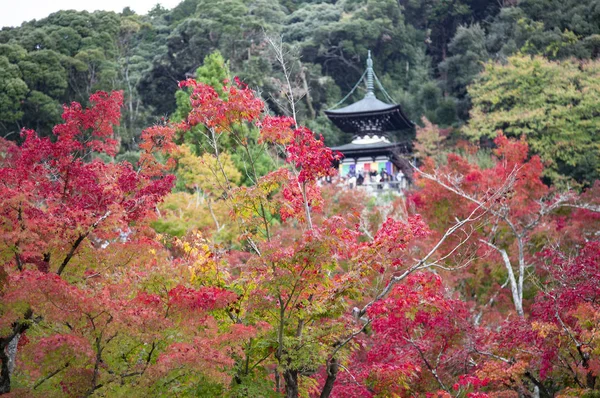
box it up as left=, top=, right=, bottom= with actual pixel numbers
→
left=0, top=0, right=600, bottom=183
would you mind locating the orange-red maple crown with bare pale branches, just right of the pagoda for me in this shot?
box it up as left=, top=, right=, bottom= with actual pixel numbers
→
left=411, top=133, right=554, bottom=276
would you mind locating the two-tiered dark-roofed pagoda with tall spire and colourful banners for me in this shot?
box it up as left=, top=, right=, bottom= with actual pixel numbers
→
left=325, top=51, right=415, bottom=177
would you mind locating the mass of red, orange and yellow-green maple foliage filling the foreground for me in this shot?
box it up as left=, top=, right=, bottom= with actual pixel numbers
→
left=0, top=80, right=600, bottom=398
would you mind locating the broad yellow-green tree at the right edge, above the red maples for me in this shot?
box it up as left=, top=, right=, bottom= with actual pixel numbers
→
left=464, top=55, right=600, bottom=184
